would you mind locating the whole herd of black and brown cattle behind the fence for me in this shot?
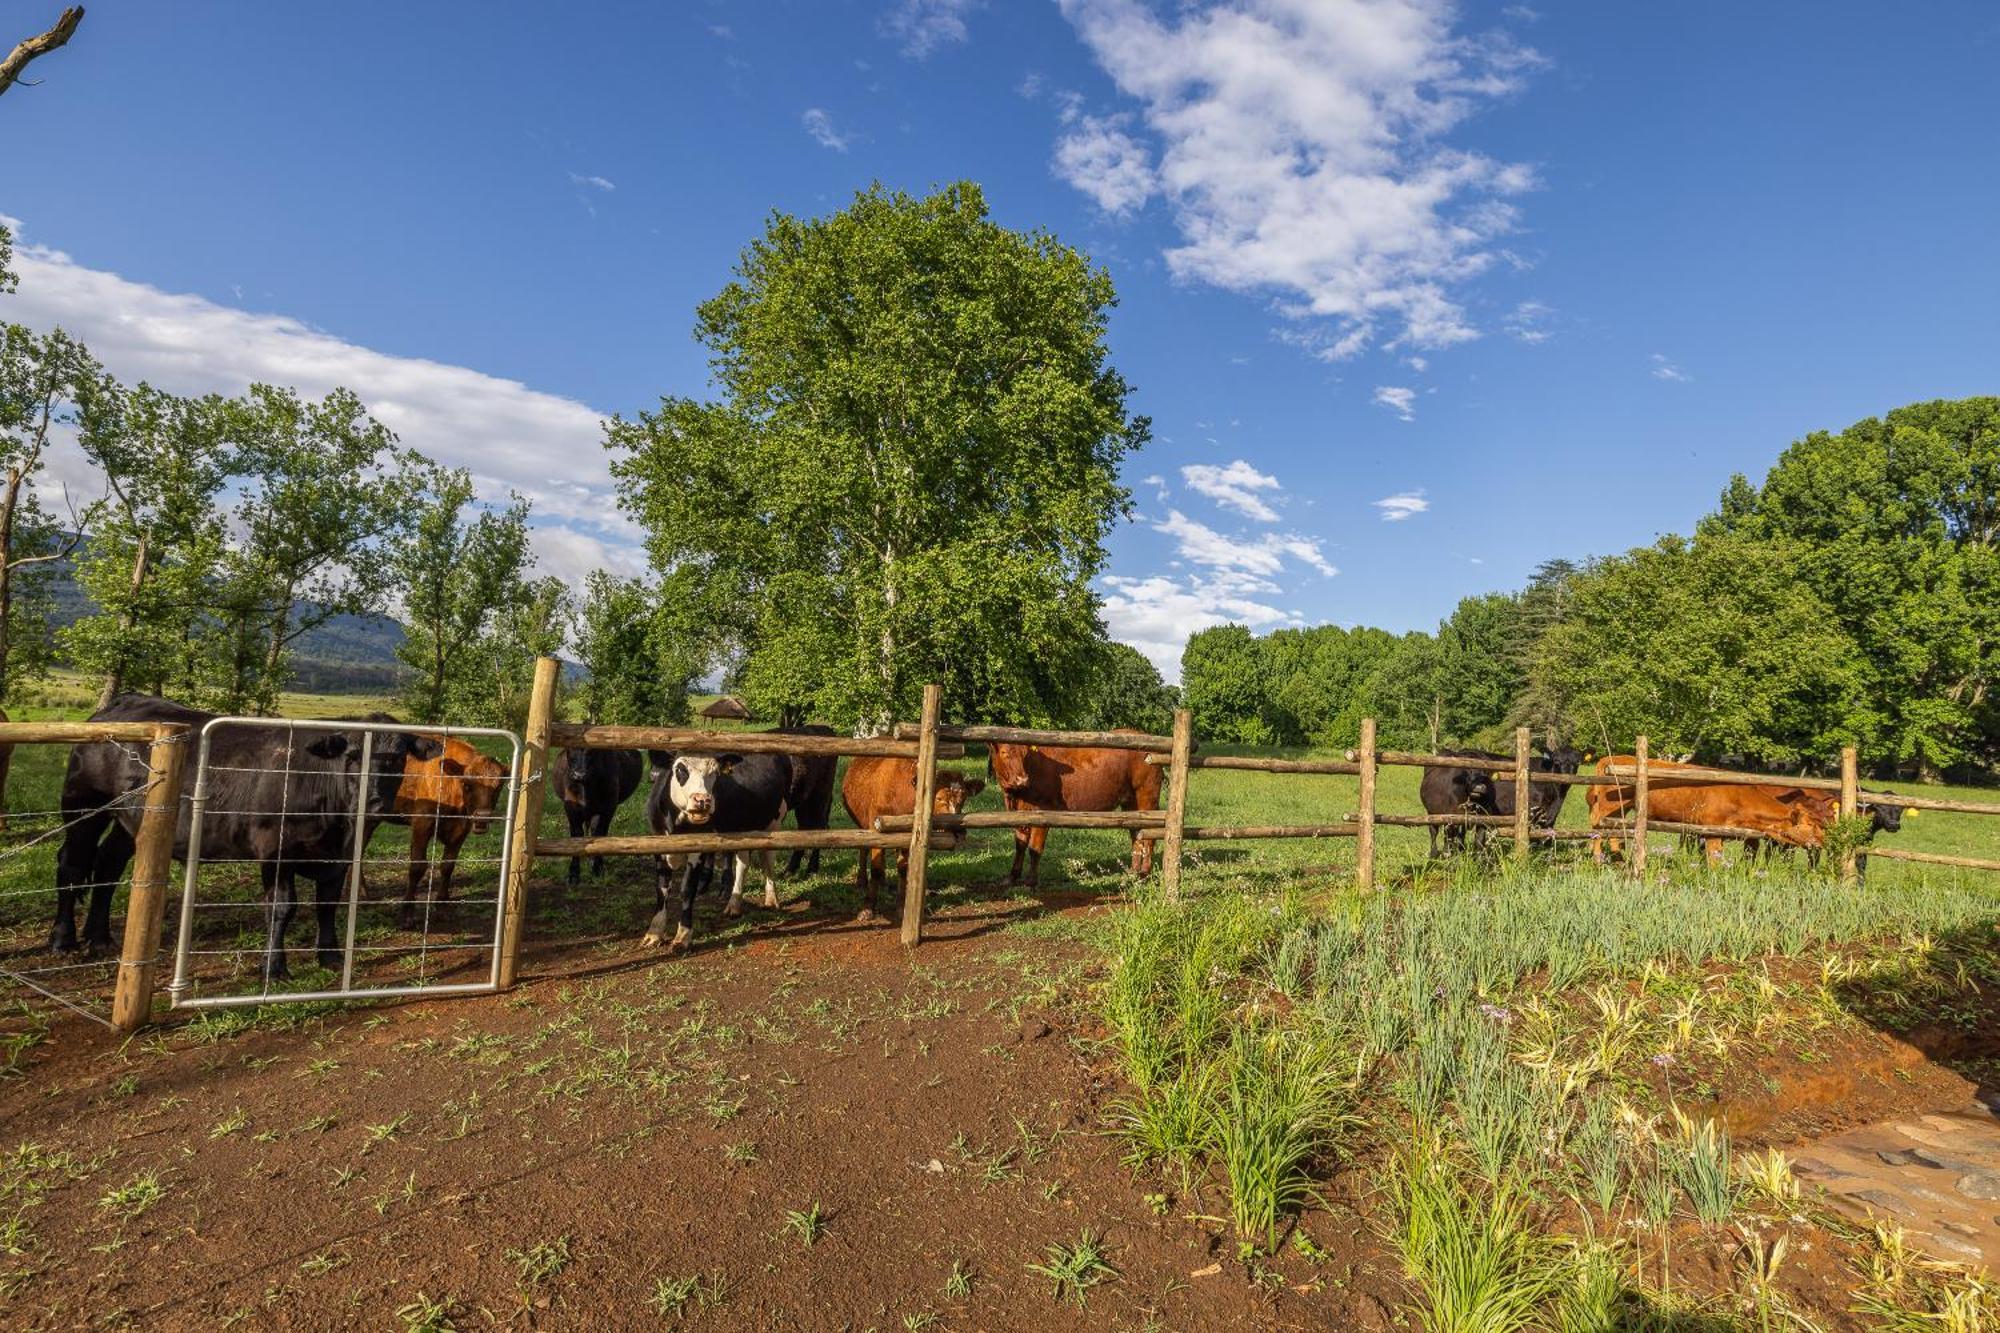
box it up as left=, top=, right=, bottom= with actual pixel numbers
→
left=48, top=695, right=1900, bottom=979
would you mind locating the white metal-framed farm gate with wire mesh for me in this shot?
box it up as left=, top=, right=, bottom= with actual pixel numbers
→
left=168, top=717, right=520, bottom=1009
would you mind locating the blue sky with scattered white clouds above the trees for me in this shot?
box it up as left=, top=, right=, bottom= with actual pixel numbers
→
left=0, top=0, right=2000, bottom=671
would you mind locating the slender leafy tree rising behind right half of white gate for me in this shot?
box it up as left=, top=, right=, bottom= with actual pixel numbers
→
left=388, top=468, right=534, bottom=723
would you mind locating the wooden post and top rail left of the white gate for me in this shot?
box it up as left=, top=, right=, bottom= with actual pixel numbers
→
left=0, top=723, right=190, bottom=1033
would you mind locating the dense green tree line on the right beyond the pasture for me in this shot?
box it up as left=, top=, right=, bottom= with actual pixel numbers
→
left=1182, top=398, right=2000, bottom=779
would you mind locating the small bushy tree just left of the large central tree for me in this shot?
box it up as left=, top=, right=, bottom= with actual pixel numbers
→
left=572, top=568, right=700, bottom=725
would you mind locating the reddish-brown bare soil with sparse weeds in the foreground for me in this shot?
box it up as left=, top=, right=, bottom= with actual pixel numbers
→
left=11, top=856, right=1992, bottom=1331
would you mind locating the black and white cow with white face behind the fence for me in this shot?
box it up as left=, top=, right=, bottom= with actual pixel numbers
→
left=640, top=751, right=792, bottom=953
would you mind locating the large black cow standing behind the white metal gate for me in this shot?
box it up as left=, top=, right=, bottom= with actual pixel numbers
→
left=48, top=695, right=442, bottom=981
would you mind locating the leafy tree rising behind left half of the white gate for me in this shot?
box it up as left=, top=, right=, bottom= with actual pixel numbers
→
left=218, top=384, right=422, bottom=713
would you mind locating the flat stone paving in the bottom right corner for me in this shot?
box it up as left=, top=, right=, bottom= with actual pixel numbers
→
left=1792, top=1105, right=2000, bottom=1273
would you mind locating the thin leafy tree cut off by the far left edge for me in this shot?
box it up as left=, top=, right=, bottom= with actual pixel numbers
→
left=0, top=324, right=112, bottom=705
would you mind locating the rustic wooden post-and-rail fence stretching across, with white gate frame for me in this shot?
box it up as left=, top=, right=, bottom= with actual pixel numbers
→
left=23, top=658, right=2000, bottom=1031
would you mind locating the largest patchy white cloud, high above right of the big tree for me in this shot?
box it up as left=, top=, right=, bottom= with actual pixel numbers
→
left=1062, top=0, right=1542, bottom=360
